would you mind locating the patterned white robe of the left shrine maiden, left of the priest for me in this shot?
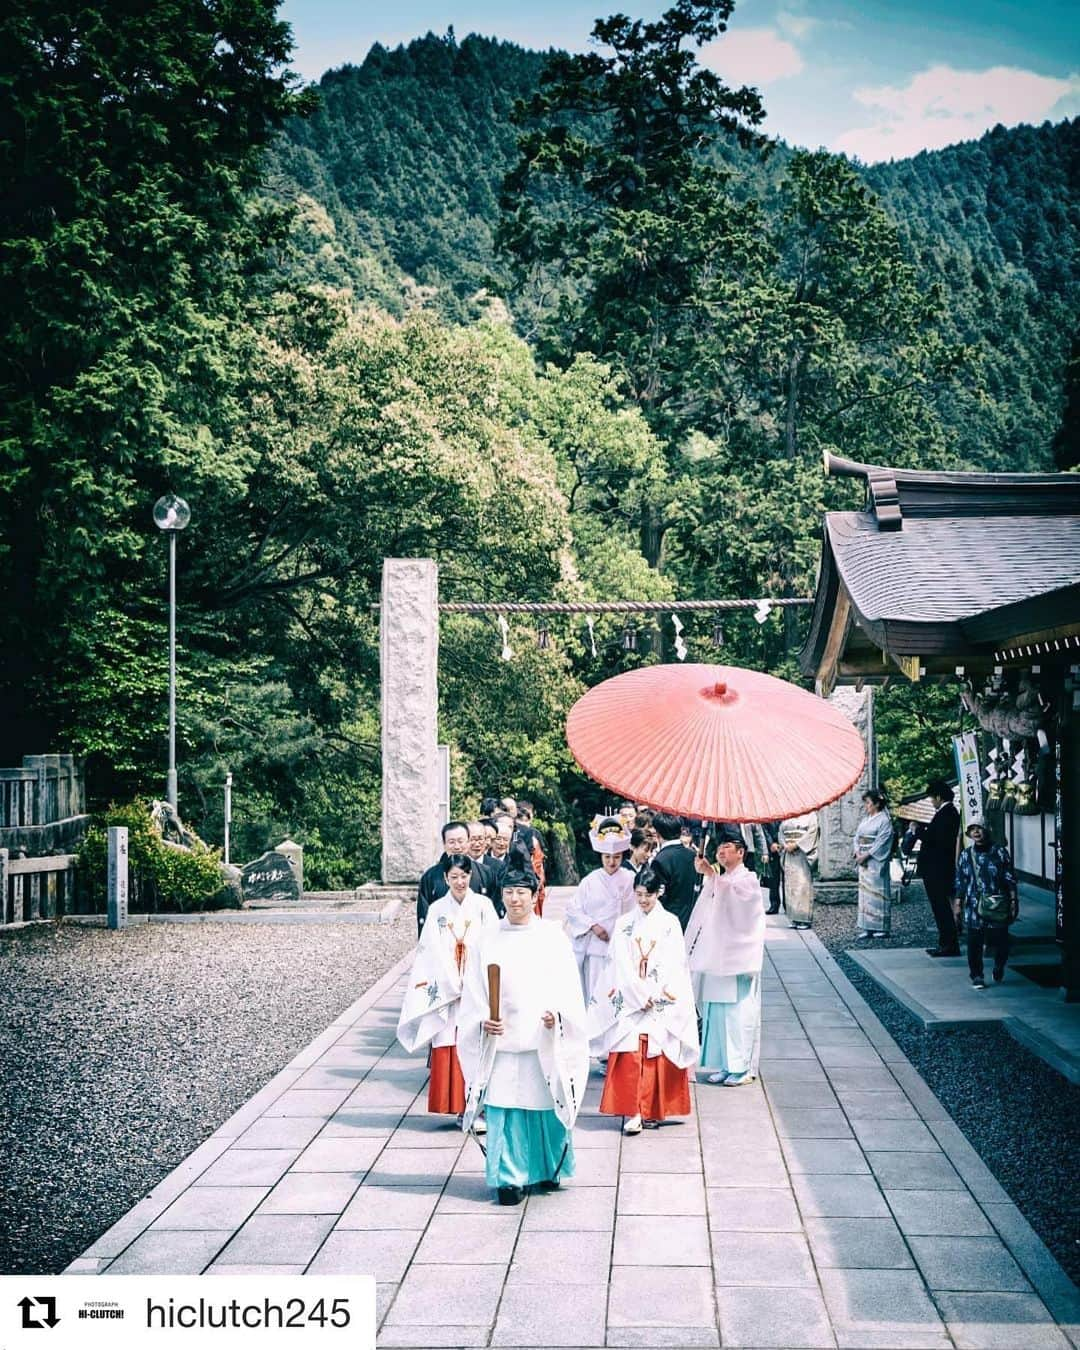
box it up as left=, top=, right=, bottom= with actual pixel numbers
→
left=397, top=891, right=498, bottom=1054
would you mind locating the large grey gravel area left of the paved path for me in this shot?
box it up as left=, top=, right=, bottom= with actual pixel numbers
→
left=0, top=906, right=416, bottom=1274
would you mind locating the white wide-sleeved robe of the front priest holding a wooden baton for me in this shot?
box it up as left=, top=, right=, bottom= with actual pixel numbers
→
left=458, top=915, right=589, bottom=1129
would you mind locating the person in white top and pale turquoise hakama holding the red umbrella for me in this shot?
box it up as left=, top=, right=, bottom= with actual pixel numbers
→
left=686, top=830, right=765, bottom=1088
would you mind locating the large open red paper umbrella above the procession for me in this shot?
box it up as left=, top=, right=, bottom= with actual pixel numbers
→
left=566, top=666, right=865, bottom=821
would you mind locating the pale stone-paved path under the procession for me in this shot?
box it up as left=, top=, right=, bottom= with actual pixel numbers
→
left=69, top=892, right=1080, bottom=1350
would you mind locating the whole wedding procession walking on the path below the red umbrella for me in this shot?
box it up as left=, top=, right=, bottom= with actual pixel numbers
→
left=398, top=801, right=813, bottom=1204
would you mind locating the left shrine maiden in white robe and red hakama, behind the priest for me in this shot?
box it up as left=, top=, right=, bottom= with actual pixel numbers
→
left=397, top=853, right=498, bottom=1134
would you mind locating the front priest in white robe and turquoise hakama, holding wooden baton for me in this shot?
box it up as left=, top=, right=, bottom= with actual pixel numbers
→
left=458, top=852, right=589, bottom=1204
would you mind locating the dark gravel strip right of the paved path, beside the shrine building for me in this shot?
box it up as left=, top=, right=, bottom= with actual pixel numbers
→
left=814, top=883, right=1080, bottom=1284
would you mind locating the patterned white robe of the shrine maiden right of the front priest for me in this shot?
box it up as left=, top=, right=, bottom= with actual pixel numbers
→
left=589, top=900, right=701, bottom=1069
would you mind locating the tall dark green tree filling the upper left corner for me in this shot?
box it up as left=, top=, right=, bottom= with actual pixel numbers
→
left=0, top=0, right=309, bottom=753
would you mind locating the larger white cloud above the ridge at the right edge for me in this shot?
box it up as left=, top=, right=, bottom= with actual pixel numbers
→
left=832, top=65, right=1080, bottom=163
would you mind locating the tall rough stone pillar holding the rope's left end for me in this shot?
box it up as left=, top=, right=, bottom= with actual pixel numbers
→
left=379, top=558, right=441, bottom=883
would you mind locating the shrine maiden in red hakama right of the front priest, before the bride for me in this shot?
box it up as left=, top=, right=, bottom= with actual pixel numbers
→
left=589, top=867, right=701, bottom=1134
